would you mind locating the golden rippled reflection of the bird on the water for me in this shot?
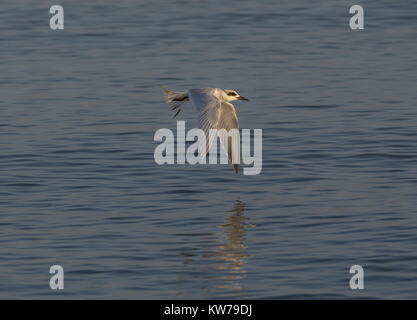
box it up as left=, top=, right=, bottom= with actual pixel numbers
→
left=211, top=200, right=254, bottom=294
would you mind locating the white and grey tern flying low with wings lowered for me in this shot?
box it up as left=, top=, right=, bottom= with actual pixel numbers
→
left=164, top=88, right=249, bottom=173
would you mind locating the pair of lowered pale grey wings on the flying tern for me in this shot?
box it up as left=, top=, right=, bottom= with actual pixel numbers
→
left=188, top=89, right=240, bottom=173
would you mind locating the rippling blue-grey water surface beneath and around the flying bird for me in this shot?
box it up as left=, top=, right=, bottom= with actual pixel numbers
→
left=0, top=0, right=417, bottom=299
